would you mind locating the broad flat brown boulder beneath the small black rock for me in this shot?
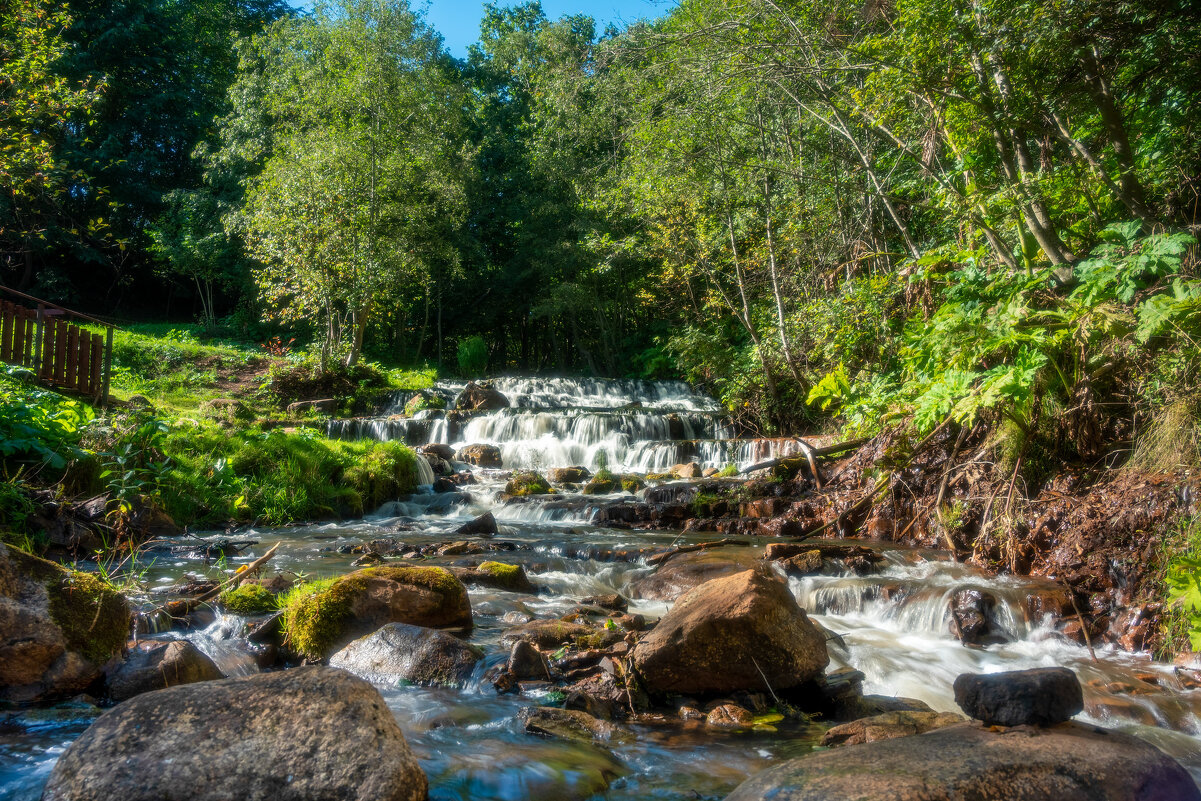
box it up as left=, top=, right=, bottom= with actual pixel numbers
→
left=725, top=723, right=1201, bottom=801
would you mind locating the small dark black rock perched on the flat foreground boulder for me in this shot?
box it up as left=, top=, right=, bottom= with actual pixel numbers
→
left=955, top=668, right=1085, bottom=725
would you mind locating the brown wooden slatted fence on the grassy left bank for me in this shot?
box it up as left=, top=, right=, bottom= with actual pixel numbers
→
left=0, top=287, right=113, bottom=405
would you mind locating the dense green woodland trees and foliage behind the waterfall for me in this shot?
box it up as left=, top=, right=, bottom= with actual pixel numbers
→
left=0, top=0, right=1201, bottom=444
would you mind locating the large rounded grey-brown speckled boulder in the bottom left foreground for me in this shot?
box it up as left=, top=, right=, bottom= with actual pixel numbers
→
left=42, top=666, right=428, bottom=801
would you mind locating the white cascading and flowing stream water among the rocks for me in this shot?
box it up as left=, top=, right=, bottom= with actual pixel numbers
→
left=0, top=379, right=1201, bottom=801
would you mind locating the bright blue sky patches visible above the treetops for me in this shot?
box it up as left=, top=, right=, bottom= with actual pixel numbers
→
left=292, top=0, right=675, bottom=58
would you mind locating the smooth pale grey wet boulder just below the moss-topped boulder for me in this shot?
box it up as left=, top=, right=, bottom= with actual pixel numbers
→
left=329, top=623, right=484, bottom=687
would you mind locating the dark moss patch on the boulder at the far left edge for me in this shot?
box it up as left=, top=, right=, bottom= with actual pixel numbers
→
left=44, top=570, right=130, bottom=665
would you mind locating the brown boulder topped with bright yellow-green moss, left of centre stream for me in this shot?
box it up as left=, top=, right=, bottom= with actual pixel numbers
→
left=283, top=566, right=472, bottom=659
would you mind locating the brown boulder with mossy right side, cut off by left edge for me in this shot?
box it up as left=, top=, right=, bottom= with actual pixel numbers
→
left=0, top=545, right=131, bottom=701
